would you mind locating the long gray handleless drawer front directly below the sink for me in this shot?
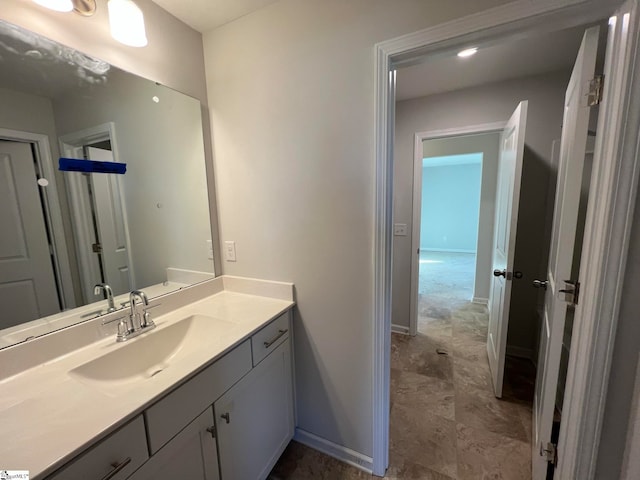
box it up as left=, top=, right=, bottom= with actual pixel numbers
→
left=144, top=340, right=251, bottom=454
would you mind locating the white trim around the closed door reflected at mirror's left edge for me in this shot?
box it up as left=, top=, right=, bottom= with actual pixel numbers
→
left=0, top=128, right=76, bottom=310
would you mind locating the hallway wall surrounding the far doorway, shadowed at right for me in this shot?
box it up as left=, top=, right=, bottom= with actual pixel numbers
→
left=393, top=72, right=569, bottom=355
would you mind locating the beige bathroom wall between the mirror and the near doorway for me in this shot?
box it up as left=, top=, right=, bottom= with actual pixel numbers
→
left=204, top=0, right=516, bottom=455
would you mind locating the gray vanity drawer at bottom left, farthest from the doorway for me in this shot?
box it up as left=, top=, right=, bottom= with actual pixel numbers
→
left=47, top=415, right=149, bottom=480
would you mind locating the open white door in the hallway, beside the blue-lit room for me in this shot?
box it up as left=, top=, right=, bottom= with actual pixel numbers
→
left=487, top=100, right=528, bottom=398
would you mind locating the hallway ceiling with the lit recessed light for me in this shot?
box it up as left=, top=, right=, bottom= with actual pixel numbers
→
left=396, top=26, right=606, bottom=101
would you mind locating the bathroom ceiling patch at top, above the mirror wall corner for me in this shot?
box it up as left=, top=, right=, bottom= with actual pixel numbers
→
left=152, top=0, right=278, bottom=33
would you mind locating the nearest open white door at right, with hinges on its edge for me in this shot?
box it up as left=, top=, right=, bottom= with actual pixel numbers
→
left=532, top=27, right=599, bottom=480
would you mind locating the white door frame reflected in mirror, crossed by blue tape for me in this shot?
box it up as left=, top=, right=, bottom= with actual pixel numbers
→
left=59, top=122, right=136, bottom=303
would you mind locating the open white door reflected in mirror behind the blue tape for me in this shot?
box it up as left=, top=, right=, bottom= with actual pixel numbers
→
left=86, top=147, right=132, bottom=295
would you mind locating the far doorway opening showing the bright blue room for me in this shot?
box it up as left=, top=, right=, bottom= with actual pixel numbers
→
left=408, top=130, right=502, bottom=335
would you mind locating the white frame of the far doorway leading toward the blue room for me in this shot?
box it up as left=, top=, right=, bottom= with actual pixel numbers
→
left=410, top=122, right=507, bottom=336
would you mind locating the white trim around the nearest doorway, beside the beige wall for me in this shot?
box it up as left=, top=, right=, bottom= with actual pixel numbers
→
left=372, top=0, right=638, bottom=479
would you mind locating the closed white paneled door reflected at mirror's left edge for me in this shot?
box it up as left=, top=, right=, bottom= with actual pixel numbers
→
left=0, top=140, right=60, bottom=328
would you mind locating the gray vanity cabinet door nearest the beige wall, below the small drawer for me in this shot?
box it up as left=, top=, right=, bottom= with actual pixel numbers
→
left=213, top=339, right=294, bottom=480
